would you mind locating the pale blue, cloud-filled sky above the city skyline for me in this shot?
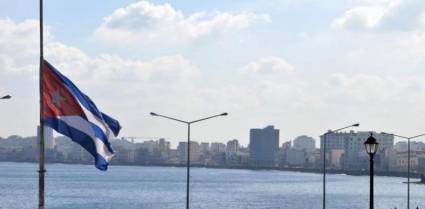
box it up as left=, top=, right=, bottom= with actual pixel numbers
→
left=0, top=0, right=425, bottom=147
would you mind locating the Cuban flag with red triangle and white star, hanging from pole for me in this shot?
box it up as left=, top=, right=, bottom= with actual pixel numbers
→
left=42, top=60, right=121, bottom=171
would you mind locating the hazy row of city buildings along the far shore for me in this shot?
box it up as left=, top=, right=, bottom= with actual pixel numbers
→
left=0, top=129, right=425, bottom=176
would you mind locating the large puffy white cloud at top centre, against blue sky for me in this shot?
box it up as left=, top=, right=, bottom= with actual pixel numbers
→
left=95, top=1, right=270, bottom=44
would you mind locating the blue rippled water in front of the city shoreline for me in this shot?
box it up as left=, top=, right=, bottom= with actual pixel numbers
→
left=0, top=163, right=425, bottom=209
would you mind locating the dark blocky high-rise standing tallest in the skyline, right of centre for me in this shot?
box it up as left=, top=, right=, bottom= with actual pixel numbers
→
left=249, top=126, right=279, bottom=166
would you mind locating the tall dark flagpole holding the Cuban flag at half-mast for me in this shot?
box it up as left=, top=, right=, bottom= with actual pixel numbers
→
left=38, top=0, right=46, bottom=209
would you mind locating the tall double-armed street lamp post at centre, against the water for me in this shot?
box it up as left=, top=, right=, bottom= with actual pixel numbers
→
left=150, top=112, right=228, bottom=209
